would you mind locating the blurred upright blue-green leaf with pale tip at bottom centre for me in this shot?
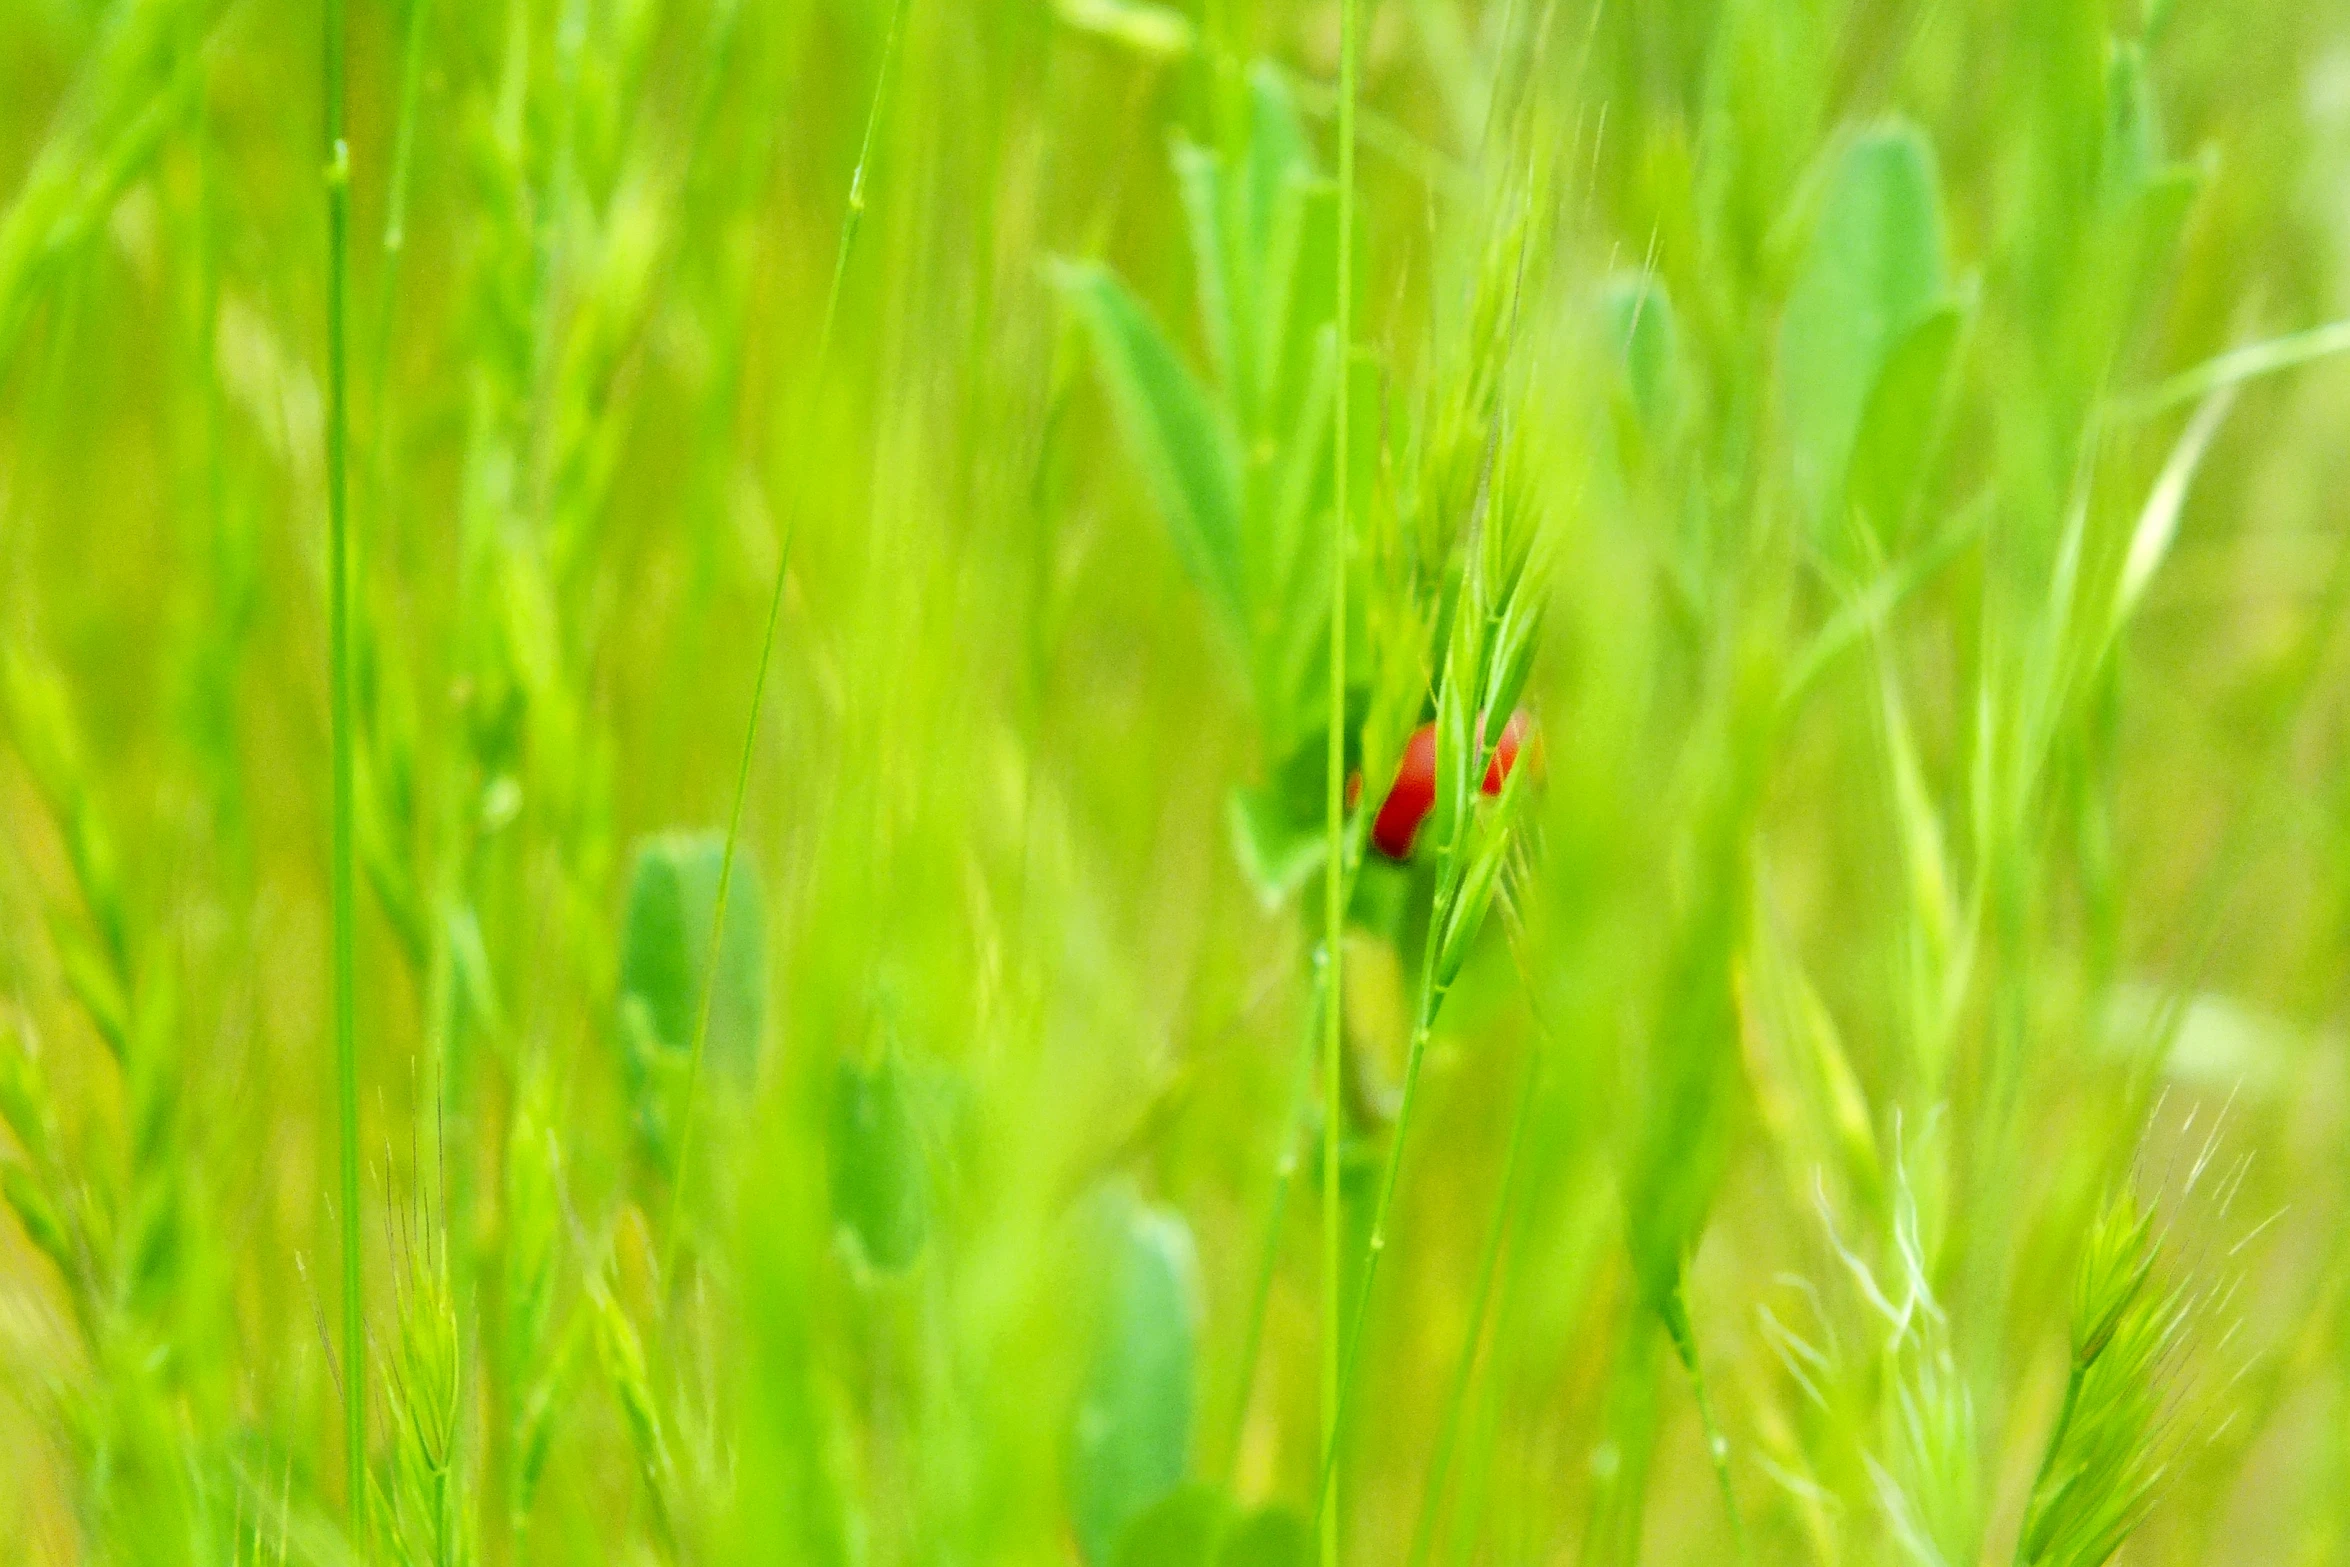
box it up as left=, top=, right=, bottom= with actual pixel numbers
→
left=1069, top=1189, right=1199, bottom=1567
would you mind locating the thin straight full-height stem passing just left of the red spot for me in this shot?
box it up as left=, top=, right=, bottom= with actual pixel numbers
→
left=1321, top=0, right=1361, bottom=1567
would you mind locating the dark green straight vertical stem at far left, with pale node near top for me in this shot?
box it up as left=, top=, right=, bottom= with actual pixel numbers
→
left=324, top=0, right=367, bottom=1544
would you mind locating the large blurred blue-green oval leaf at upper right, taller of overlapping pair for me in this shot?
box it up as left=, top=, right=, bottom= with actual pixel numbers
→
left=1779, top=125, right=1943, bottom=507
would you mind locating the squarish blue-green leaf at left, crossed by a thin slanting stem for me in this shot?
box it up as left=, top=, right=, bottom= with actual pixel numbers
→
left=620, top=832, right=766, bottom=1078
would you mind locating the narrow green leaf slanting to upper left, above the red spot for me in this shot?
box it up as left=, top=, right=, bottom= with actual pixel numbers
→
left=1053, top=261, right=1248, bottom=651
